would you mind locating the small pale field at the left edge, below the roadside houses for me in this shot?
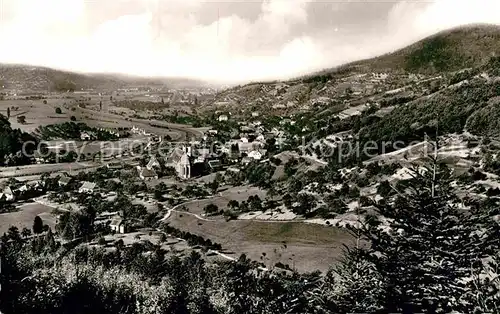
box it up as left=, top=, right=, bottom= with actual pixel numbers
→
left=0, top=203, right=56, bottom=234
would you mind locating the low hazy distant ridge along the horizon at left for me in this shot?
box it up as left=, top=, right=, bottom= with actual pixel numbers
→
left=0, top=64, right=206, bottom=91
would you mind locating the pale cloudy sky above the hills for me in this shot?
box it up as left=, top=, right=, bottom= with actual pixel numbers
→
left=0, top=0, right=500, bottom=83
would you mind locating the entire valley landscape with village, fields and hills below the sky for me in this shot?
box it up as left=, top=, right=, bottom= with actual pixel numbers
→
left=0, top=25, right=500, bottom=313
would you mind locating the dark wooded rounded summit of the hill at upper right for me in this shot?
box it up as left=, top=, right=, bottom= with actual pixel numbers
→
left=312, top=24, right=500, bottom=76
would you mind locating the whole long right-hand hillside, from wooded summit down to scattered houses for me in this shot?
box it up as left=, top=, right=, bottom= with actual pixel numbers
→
left=205, top=25, right=500, bottom=113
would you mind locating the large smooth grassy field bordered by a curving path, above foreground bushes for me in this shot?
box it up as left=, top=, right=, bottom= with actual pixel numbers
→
left=166, top=212, right=354, bottom=272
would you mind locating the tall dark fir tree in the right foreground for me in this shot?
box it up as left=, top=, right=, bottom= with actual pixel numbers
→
left=352, top=159, right=499, bottom=312
